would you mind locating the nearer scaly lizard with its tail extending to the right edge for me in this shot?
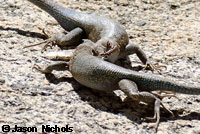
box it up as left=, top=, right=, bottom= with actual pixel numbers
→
left=34, top=40, right=200, bottom=129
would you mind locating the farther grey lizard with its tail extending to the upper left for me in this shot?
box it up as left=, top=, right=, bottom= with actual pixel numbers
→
left=25, top=0, right=152, bottom=69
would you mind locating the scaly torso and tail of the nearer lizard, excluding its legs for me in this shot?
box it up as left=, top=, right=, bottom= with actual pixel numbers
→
left=69, top=43, right=200, bottom=95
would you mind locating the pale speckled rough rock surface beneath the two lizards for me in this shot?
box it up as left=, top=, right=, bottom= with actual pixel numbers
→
left=0, top=0, right=200, bottom=134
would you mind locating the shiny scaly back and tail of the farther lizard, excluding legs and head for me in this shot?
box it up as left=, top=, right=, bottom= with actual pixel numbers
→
left=28, top=0, right=128, bottom=45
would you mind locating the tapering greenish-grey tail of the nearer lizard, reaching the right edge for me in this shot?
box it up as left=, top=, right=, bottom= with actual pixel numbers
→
left=129, top=72, right=200, bottom=95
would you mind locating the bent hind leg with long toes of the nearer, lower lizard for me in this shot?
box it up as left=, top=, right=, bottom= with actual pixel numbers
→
left=118, top=79, right=173, bottom=129
